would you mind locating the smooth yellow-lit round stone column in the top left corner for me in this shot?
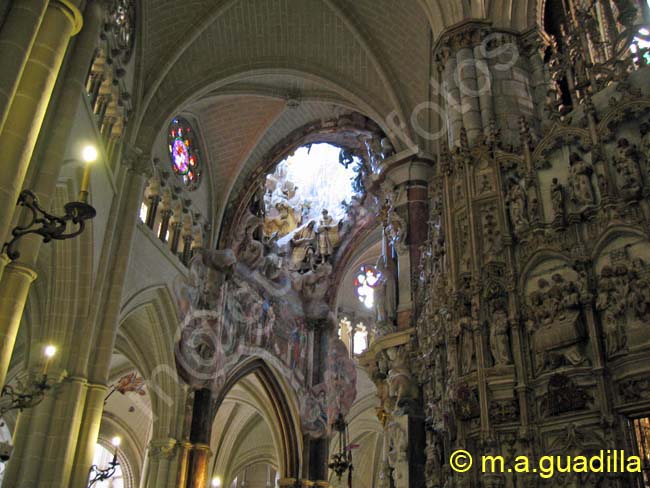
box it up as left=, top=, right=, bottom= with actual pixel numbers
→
left=0, top=0, right=82, bottom=255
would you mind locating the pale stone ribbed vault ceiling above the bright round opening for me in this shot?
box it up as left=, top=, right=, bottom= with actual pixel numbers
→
left=135, top=0, right=541, bottom=223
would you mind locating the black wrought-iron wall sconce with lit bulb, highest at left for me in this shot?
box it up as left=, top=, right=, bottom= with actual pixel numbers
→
left=3, top=146, right=97, bottom=261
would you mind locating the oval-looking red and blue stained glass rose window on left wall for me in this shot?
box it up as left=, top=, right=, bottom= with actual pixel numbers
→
left=167, top=117, right=201, bottom=190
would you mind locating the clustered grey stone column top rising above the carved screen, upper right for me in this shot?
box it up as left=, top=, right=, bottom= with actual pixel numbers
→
left=433, top=21, right=539, bottom=146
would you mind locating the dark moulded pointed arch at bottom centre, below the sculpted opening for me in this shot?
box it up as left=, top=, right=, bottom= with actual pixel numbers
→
left=210, top=357, right=301, bottom=478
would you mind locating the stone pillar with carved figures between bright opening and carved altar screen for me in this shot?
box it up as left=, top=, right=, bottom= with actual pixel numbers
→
left=360, top=149, right=433, bottom=488
